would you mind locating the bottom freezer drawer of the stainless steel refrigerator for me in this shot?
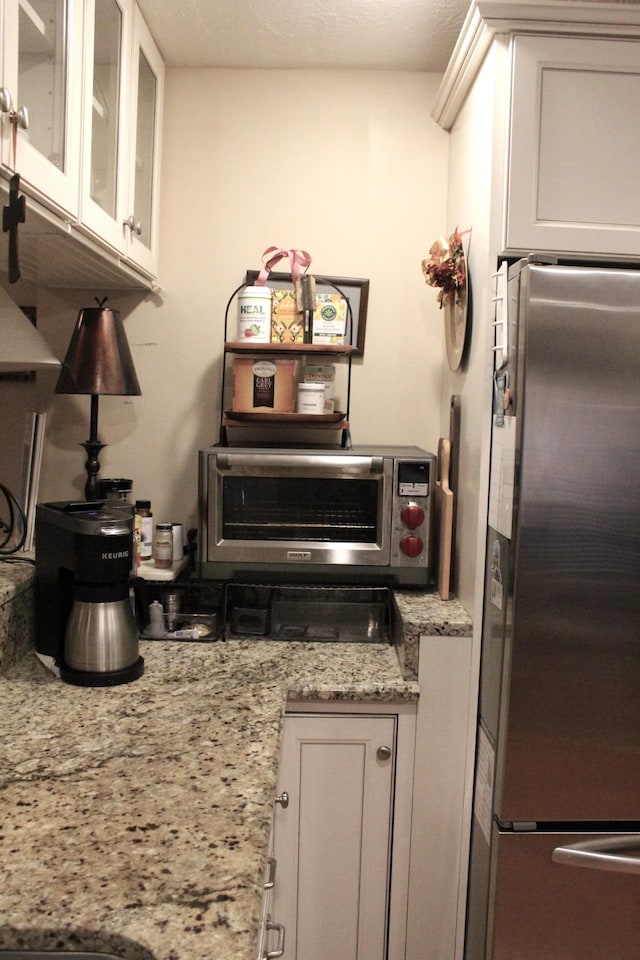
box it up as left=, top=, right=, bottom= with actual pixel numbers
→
left=488, top=833, right=640, bottom=960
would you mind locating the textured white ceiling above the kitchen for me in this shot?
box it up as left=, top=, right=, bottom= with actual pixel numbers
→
left=139, top=0, right=469, bottom=73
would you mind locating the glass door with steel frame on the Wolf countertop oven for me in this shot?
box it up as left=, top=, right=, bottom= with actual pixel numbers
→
left=208, top=451, right=393, bottom=579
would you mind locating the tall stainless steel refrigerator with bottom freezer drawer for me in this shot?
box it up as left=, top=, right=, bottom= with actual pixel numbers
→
left=465, top=260, right=640, bottom=960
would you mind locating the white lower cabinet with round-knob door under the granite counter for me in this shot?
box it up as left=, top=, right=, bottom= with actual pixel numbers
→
left=273, top=704, right=415, bottom=960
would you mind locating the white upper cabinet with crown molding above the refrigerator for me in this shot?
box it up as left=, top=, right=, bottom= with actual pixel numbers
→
left=433, top=0, right=640, bottom=261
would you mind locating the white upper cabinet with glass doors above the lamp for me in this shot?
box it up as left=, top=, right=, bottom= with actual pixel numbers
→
left=0, top=0, right=164, bottom=289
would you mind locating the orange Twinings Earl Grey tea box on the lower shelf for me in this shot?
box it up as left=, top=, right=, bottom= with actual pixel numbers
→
left=233, top=357, right=295, bottom=413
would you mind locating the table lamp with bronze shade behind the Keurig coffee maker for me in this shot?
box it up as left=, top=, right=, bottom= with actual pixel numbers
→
left=56, top=298, right=142, bottom=500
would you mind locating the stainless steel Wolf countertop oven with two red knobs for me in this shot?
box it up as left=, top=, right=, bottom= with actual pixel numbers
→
left=199, top=446, right=435, bottom=586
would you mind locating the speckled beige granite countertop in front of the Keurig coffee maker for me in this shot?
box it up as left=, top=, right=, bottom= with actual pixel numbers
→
left=0, top=568, right=470, bottom=960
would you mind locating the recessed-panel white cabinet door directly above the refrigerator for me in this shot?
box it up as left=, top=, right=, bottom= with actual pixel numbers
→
left=505, top=36, right=640, bottom=258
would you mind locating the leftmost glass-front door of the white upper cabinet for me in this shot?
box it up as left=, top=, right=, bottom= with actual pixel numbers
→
left=2, top=0, right=83, bottom=217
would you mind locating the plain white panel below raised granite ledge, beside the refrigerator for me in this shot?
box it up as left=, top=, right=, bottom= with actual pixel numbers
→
left=406, top=636, right=476, bottom=960
